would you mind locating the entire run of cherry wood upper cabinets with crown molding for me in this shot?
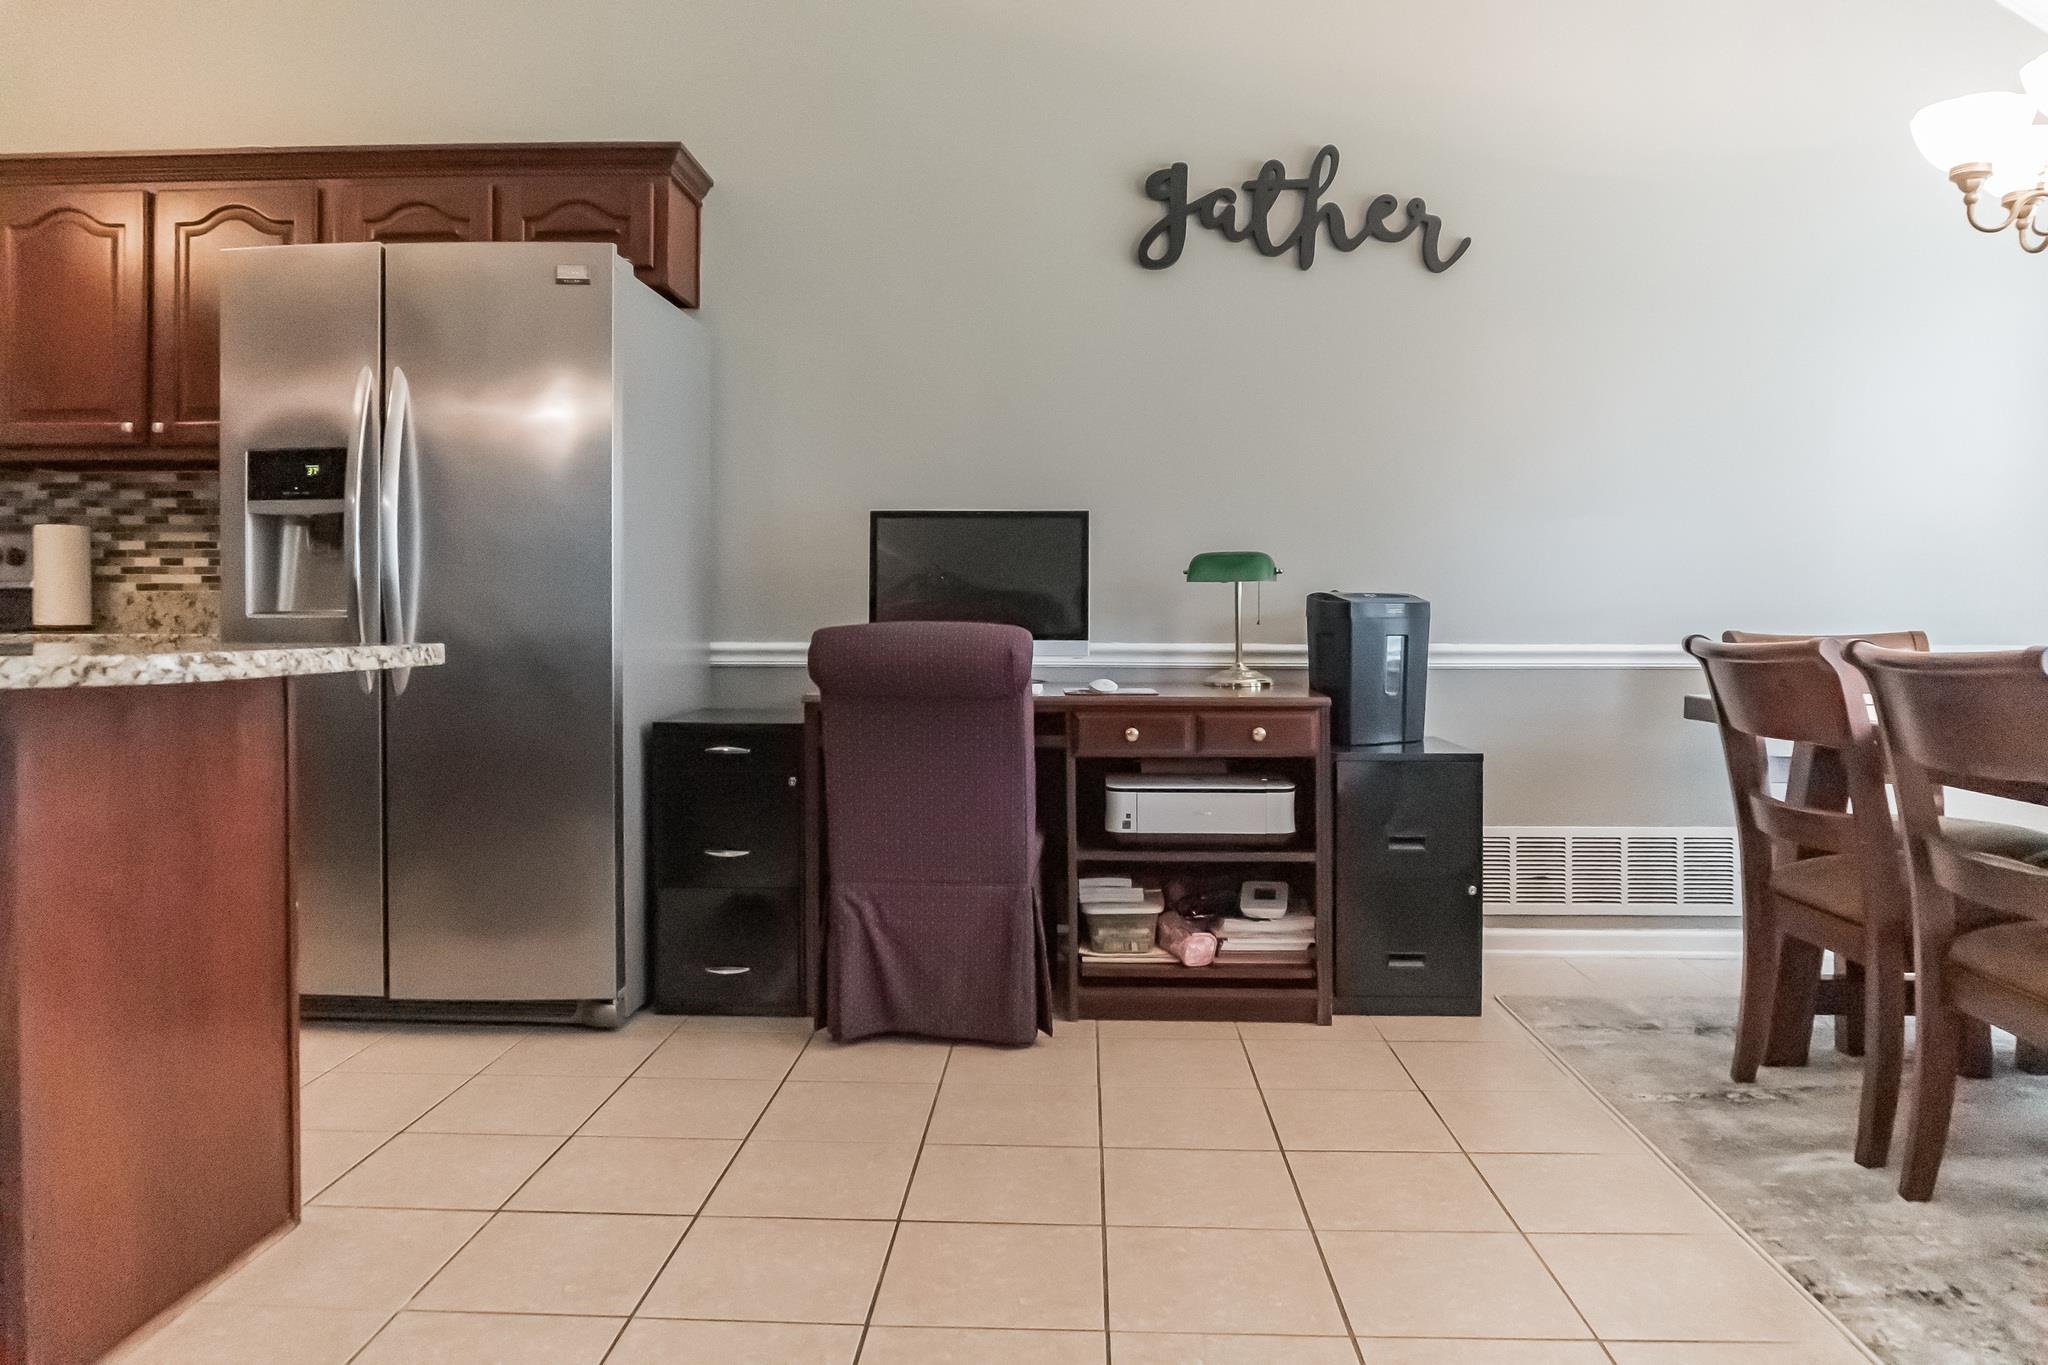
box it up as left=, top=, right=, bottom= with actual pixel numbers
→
left=0, top=143, right=711, bottom=465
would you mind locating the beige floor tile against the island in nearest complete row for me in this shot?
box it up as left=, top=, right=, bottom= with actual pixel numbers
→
left=207, top=1207, right=489, bottom=1312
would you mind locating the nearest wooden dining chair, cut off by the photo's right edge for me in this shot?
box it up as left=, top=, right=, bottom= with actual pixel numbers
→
left=1829, top=643, right=2048, bottom=1199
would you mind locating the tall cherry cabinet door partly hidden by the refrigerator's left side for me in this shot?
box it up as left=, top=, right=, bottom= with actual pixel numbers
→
left=150, top=180, right=319, bottom=446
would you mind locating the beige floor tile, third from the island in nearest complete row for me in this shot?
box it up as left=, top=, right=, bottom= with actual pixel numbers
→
left=639, top=1218, right=893, bottom=1324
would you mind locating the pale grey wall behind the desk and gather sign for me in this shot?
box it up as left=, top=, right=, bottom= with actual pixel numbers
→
left=0, top=0, right=2048, bottom=823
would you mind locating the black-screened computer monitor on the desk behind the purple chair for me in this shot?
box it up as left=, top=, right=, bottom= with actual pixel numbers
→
left=868, top=512, right=1087, bottom=657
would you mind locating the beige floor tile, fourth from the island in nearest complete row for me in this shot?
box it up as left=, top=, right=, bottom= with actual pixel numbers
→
left=874, top=1224, right=1102, bottom=1332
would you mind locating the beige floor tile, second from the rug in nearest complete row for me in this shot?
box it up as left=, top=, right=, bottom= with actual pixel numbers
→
left=1319, top=1232, right=1591, bottom=1340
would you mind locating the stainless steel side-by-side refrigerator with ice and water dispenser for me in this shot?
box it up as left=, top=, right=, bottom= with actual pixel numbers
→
left=219, top=244, right=709, bottom=1025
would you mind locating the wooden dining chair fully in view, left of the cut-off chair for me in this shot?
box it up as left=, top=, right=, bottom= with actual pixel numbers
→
left=1686, top=634, right=1911, bottom=1166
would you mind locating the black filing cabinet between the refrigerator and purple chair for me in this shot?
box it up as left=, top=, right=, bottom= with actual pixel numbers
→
left=647, top=710, right=803, bottom=1015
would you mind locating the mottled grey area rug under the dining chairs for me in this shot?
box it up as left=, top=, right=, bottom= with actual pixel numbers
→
left=1503, top=997, right=2048, bottom=1365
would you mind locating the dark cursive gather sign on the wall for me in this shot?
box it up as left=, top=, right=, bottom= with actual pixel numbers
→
left=1139, top=145, right=1473, bottom=274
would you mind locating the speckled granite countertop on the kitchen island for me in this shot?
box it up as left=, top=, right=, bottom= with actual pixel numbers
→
left=0, top=634, right=444, bottom=692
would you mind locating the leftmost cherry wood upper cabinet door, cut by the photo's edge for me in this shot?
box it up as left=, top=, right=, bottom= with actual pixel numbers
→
left=0, top=186, right=147, bottom=446
